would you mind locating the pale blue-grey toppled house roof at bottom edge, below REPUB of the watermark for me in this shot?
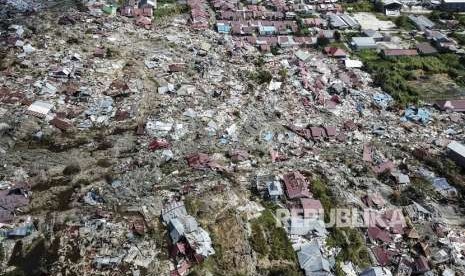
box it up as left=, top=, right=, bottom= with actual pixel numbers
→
left=297, top=241, right=331, bottom=276
